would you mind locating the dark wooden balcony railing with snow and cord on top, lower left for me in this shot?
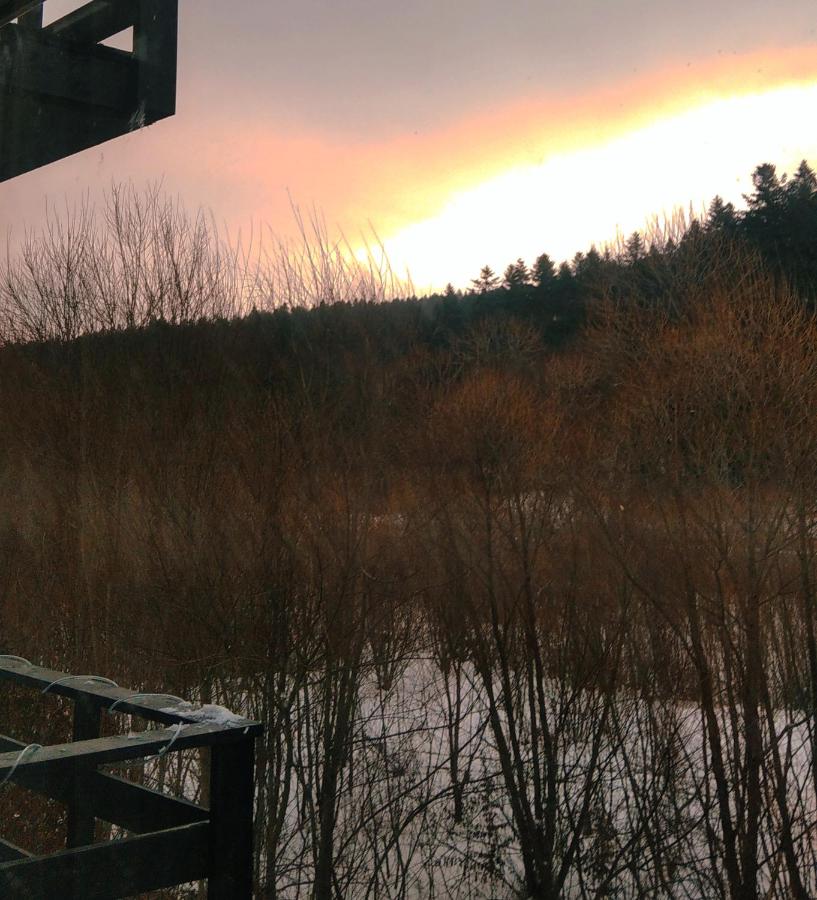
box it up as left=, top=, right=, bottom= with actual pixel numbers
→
left=0, top=658, right=262, bottom=900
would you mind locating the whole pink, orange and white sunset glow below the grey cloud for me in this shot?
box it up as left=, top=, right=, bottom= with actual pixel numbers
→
left=0, top=36, right=817, bottom=293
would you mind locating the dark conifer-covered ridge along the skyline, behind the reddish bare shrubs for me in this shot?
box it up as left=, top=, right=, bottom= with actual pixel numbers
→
left=0, top=161, right=817, bottom=380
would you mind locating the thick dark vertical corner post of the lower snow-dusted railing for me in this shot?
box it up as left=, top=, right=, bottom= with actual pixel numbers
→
left=207, top=737, right=255, bottom=900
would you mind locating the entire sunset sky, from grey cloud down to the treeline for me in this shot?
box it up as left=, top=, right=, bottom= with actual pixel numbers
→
left=0, top=0, right=817, bottom=291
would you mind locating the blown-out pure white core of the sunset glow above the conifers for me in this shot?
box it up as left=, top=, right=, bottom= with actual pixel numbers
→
left=374, top=82, right=817, bottom=289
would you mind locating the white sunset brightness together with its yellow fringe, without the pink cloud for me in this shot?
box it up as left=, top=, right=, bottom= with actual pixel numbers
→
left=348, top=51, right=817, bottom=291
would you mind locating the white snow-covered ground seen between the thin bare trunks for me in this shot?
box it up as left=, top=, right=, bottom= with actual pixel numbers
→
left=127, top=657, right=817, bottom=900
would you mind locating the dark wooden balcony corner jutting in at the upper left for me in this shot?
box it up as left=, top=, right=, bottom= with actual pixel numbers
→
left=0, top=0, right=178, bottom=181
